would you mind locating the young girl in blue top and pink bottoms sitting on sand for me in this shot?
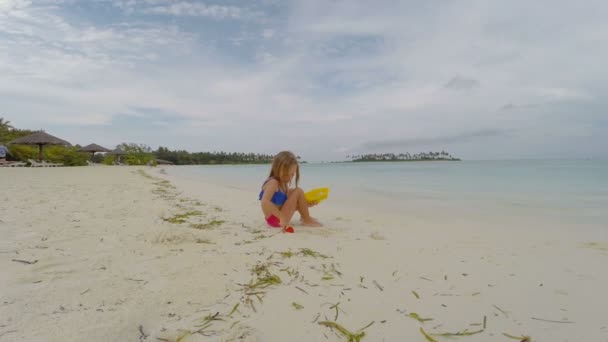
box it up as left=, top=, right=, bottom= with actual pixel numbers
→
left=260, top=151, right=321, bottom=232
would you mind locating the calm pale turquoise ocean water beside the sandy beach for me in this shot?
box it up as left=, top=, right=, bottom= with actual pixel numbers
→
left=169, top=160, right=608, bottom=232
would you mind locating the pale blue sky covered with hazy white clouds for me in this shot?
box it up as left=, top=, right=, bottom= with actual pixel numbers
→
left=0, top=0, right=608, bottom=161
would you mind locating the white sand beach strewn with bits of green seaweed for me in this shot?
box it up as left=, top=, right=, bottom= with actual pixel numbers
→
left=0, top=167, right=608, bottom=341
